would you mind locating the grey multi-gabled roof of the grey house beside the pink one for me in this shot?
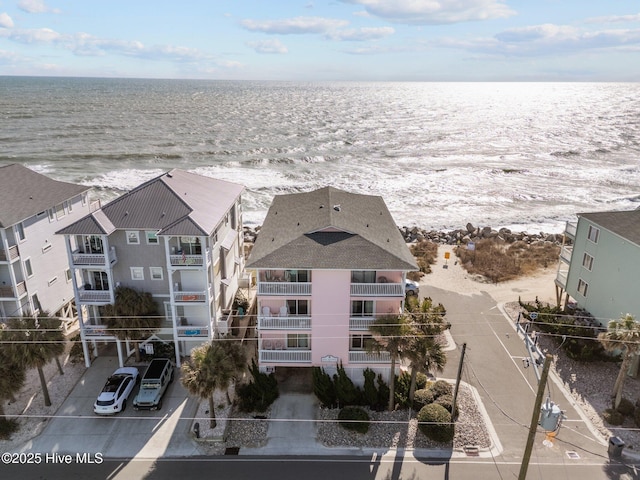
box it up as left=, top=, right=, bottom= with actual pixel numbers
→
left=57, top=169, right=244, bottom=235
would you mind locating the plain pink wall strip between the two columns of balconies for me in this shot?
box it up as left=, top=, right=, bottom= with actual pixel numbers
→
left=311, top=270, right=351, bottom=366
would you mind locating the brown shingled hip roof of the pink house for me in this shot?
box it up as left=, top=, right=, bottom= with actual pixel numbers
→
left=242, top=187, right=418, bottom=270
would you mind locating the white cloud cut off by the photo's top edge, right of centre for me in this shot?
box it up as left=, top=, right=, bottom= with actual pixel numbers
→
left=341, top=0, right=515, bottom=25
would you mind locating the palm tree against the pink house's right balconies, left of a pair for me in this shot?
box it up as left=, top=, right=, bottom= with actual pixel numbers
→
left=368, top=315, right=412, bottom=411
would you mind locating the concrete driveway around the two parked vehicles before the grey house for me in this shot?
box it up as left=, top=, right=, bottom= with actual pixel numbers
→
left=19, top=356, right=198, bottom=458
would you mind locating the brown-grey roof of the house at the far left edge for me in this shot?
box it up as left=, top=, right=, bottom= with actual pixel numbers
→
left=0, top=163, right=90, bottom=228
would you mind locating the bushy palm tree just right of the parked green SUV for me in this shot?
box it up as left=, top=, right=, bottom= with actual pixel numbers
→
left=180, top=339, right=247, bottom=428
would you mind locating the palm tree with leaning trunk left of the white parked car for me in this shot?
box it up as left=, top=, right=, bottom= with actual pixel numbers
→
left=3, top=313, right=65, bottom=407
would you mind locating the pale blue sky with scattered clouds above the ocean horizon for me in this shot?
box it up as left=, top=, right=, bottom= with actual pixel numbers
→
left=0, top=0, right=640, bottom=81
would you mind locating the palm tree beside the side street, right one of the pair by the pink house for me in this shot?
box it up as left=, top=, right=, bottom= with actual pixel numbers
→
left=406, top=297, right=449, bottom=403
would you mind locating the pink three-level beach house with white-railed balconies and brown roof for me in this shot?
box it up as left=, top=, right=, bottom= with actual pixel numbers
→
left=247, top=187, right=418, bottom=381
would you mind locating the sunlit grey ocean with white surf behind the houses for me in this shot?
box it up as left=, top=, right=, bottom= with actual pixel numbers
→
left=0, top=77, right=640, bottom=232
